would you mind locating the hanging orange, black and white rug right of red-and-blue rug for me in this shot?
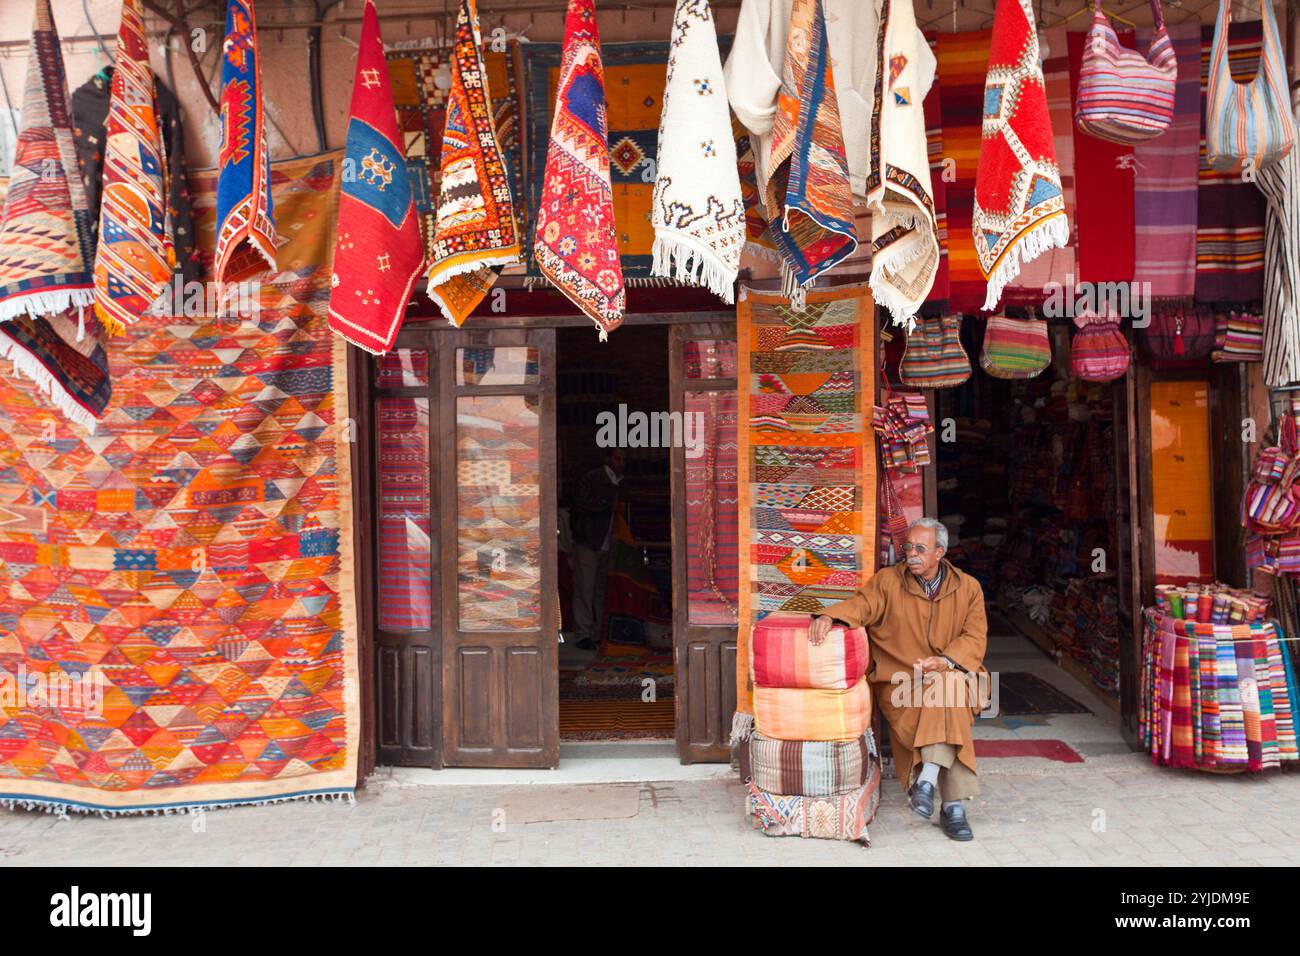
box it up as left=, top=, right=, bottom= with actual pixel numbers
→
left=428, top=0, right=520, bottom=325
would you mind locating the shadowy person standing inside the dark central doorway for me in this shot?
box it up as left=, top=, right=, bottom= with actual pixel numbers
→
left=569, top=447, right=623, bottom=650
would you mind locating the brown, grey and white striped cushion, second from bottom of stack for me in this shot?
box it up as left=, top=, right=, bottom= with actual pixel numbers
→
left=738, top=730, right=880, bottom=797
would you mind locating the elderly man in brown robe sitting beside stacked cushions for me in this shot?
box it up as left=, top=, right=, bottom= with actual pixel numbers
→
left=810, top=518, right=987, bottom=840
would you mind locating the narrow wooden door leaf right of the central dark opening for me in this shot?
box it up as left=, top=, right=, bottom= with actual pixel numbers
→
left=668, top=323, right=740, bottom=763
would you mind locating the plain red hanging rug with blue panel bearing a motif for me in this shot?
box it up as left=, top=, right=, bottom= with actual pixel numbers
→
left=329, top=0, right=424, bottom=354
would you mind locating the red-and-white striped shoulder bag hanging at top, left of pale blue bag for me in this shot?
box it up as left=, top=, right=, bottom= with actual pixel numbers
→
left=1074, top=0, right=1178, bottom=144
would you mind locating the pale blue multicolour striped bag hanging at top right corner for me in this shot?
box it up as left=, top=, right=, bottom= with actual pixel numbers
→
left=1205, top=0, right=1296, bottom=170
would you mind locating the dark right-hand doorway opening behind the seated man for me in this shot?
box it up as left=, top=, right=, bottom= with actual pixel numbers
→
left=935, top=323, right=1131, bottom=721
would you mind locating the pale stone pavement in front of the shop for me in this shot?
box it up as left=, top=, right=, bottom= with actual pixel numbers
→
left=0, top=637, right=1300, bottom=866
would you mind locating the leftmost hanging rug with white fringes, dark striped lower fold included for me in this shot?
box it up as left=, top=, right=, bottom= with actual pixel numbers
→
left=0, top=0, right=112, bottom=429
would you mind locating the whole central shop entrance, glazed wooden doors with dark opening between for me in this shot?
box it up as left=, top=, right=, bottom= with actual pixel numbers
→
left=356, top=316, right=738, bottom=767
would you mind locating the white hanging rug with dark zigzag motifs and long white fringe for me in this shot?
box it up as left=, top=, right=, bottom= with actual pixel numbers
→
left=650, top=0, right=745, bottom=303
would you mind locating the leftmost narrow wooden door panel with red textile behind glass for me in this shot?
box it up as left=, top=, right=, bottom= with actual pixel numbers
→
left=369, top=328, right=442, bottom=767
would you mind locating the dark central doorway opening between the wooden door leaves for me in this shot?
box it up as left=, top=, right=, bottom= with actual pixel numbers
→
left=555, top=325, right=690, bottom=743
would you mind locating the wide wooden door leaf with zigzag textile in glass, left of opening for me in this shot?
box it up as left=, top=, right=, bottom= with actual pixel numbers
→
left=436, top=329, right=559, bottom=767
